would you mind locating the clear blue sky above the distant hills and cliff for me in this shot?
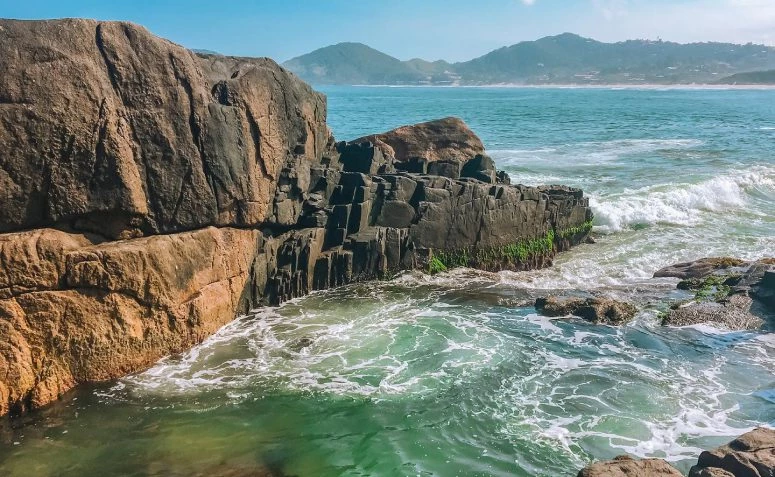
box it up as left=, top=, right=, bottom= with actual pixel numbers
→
left=0, top=0, right=775, bottom=61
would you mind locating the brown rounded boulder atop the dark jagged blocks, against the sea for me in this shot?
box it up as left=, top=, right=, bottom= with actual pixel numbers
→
left=352, top=117, right=484, bottom=163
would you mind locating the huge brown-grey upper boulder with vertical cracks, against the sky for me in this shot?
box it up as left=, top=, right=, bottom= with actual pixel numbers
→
left=0, top=19, right=329, bottom=238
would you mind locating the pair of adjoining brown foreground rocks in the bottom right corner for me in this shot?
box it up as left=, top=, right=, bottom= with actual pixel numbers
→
left=578, top=427, right=775, bottom=477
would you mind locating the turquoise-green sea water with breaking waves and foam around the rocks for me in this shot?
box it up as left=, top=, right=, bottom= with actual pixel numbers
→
left=0, top=88, right=775, bottom=477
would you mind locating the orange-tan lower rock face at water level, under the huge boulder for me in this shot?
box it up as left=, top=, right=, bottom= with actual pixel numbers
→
left=0, top=227, right=261, bottom=414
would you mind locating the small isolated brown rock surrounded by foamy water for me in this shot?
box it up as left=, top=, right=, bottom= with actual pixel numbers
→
left=535, top=296, right=638, bottom=325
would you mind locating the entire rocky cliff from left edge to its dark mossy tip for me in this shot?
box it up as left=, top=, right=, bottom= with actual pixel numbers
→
left=0, top=20, right=591, bottom=414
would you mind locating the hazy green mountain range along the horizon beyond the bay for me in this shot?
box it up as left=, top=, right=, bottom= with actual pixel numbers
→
left=284, top=33, right=775, bottom=85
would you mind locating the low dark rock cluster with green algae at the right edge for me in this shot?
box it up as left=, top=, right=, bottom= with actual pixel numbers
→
left=654, top=257, right=775, bottom=330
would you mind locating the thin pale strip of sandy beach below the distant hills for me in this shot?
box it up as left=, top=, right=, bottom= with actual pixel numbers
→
left=328, top=83, right=775, bottom=91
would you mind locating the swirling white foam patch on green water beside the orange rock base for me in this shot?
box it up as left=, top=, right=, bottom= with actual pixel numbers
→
left=114, top=300, right=503, bottom=399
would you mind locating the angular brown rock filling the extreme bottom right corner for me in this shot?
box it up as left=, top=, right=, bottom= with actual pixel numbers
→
left=689, top=427, right=775, bottom=477
